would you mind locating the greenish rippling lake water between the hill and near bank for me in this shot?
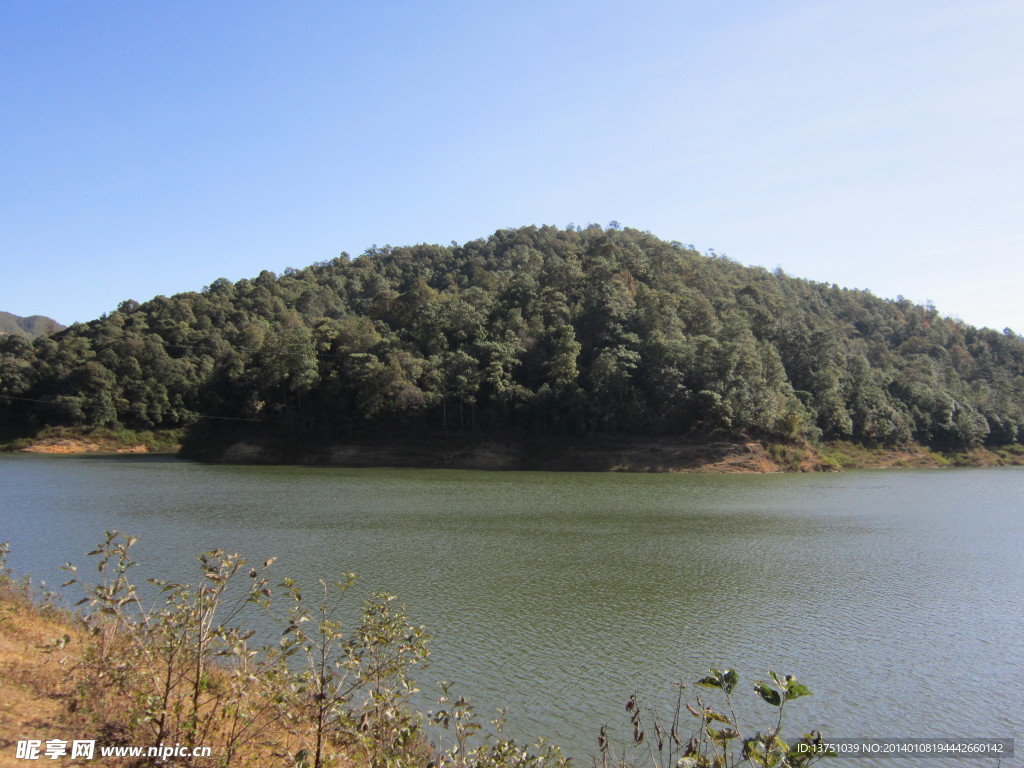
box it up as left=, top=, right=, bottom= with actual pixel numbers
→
left=0, top=455, right=1024, bottom=766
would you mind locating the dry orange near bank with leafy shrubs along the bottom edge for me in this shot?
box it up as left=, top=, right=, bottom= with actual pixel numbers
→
left=0, top=531, right=821, bottom=768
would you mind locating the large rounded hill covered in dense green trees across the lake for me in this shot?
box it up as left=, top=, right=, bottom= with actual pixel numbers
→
left=0, top=225, right=1024, bottom=447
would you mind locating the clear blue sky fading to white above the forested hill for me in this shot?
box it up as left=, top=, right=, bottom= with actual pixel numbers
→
left=0, top=0, right=1024, bottom=333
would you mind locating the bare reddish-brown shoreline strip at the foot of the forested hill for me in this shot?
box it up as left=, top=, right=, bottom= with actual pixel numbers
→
left=3, top=430, right=1024, bottom=474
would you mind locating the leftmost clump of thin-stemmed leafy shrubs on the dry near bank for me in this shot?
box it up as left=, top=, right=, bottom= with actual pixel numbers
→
left=63, top=531, right=279, bottom=765
